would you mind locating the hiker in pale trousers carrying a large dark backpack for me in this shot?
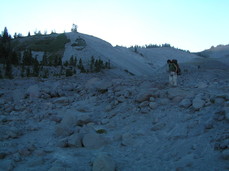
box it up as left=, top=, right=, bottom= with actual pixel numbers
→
left=167, top=60, right=178, bottom=86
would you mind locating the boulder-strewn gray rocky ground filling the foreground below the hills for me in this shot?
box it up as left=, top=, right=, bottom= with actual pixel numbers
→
left=0, top=56, right=229, bottom=171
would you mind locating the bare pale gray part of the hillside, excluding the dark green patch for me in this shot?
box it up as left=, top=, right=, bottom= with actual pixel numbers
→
left=63, top=33, right=200, bottom=76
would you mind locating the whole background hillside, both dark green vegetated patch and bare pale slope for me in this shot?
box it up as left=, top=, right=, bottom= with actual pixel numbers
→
left=10, top=32, right=198, bottom=76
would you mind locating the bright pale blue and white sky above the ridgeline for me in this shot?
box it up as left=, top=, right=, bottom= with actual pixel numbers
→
left=0, top=0, right=229, bottom=52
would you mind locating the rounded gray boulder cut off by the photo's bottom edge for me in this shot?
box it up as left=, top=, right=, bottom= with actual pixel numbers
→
left=92, top=154, right=115, bottom=171
